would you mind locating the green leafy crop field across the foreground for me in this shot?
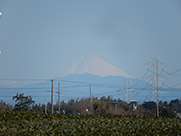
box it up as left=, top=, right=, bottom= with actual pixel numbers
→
left=0, top=112, right=181, bottom=136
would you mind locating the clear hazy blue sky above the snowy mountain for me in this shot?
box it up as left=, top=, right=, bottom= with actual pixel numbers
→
left=0, top=0, right=181, bottom=84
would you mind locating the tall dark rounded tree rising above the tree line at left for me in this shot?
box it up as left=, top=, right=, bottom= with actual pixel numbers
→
left=13, top=93, right=35, bottom=111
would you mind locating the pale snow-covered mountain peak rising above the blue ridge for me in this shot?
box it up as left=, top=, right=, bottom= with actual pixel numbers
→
left=66, top=56, right=133, bottom=78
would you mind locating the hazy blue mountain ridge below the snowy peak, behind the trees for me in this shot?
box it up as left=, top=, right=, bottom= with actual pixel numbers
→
left=0, top=74, right=181, bottom=104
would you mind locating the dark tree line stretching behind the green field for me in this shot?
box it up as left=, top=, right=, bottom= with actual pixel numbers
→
left=0, top=94, right=181, bottom=117
